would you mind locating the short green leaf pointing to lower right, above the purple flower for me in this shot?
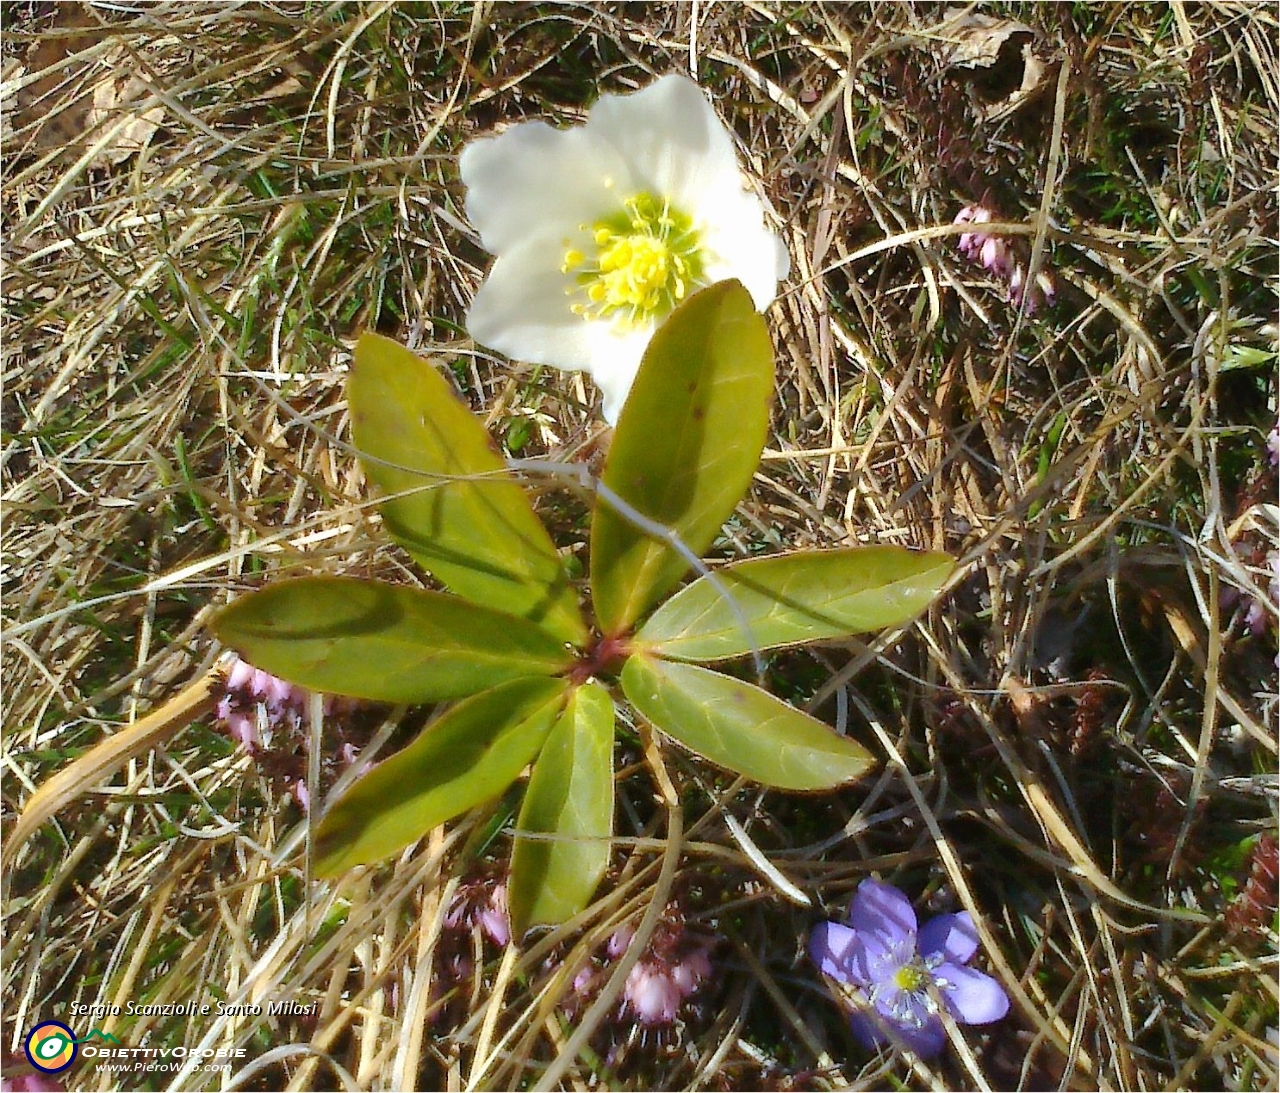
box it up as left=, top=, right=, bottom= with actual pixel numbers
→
left=622, top=655, right=874, bottom=790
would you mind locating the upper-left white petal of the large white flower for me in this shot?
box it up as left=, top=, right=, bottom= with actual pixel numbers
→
left=458, top=122, right=635, bottom=254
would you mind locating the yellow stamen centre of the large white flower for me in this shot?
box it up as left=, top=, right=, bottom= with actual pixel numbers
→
left=561, top=193, right=703, bottom=330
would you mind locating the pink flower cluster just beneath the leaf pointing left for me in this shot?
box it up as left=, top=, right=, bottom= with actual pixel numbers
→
left=214, top=657, right=362, bottom=809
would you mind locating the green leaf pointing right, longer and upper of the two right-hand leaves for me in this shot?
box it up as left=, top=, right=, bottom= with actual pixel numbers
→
left=636, top=547, right=955, bottom=660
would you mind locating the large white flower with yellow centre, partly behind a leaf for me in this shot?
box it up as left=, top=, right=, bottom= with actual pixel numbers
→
left=458, top=76, right=790, bottom=424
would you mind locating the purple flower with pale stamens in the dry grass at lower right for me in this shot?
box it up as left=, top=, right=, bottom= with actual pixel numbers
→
left=809, top=879, right=1009, bottom=1058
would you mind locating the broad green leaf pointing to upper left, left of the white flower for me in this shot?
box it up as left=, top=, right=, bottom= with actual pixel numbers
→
left=347, top=334, right=586, bottom=646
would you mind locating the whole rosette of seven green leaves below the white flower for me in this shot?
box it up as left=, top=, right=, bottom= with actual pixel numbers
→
left=214, top=280, right=952, bottom=936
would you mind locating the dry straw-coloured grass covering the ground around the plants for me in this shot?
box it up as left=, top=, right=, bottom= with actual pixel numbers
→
left=3, top=0, right=1280, bottom=1089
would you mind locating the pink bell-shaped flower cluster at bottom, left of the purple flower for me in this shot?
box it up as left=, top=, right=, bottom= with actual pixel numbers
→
left=573, top=921, right=714, bottom=1026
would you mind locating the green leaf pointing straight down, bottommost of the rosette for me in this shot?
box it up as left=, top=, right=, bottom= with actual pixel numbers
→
left=509, top=682, right=613, bottom=937
